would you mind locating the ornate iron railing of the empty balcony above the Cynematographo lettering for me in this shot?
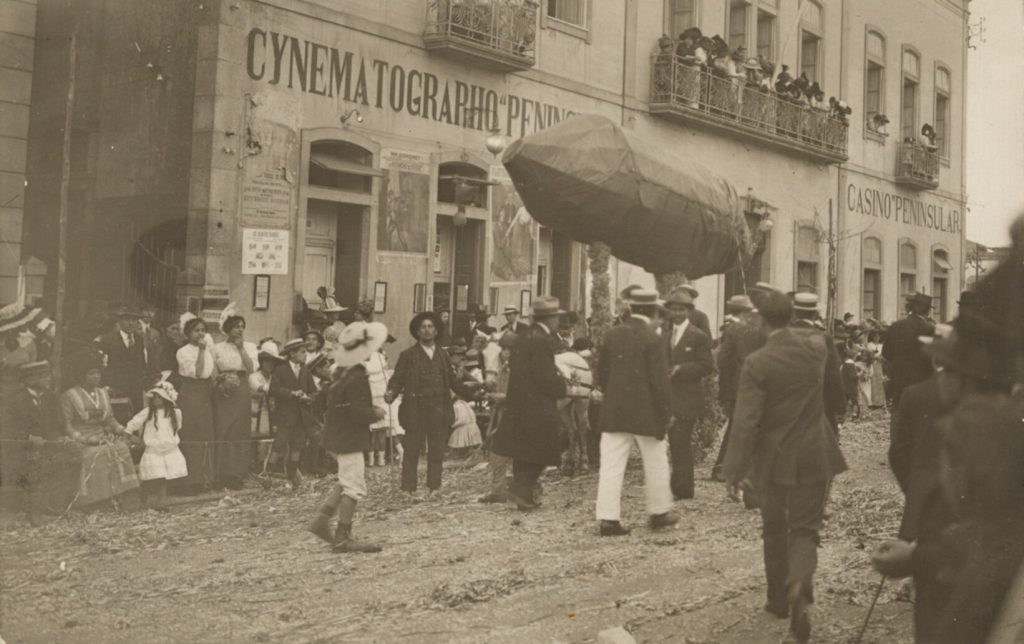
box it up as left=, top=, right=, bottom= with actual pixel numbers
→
left=424, top=0, right=538, bottom=67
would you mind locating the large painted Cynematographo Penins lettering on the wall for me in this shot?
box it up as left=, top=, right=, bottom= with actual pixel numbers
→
left=237, top=28, right=575, bottom=137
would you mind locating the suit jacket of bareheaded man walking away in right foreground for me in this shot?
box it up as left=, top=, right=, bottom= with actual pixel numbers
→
left=725, top=328, right=846, bottom=485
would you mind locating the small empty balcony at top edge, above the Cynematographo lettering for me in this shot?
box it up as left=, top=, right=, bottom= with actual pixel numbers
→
left=423, top=0, right=538, bottom=72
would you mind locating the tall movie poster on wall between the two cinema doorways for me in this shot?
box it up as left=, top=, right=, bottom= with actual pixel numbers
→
left=377, top=149, right=430, bottom=253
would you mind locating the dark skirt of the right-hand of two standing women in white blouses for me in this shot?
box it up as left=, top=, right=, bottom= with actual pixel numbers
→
left=213, top=376, right=254, bottom=482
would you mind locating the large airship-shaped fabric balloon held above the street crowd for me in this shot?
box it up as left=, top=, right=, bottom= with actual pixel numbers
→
left=502, top=115, right=750, bottom=278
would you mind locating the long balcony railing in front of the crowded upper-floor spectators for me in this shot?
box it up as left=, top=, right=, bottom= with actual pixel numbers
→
left=650, top=54, right=849, bottom=163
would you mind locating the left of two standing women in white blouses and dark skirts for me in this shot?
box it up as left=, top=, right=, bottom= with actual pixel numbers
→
left=176, top=313, right=216, bottom=491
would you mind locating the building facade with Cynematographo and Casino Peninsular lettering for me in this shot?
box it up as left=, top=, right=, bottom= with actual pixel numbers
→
left=23, top=0, right=967, bottom=352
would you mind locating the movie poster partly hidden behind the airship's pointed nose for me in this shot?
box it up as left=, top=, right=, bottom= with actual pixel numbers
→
left=490, top=168, right=538, bottom=282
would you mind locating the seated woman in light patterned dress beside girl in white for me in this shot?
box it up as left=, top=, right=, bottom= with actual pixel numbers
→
left=60, top=349, right=138, bottom=507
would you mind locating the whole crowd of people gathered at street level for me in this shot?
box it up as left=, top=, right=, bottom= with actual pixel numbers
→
left=0, top=218, right=1024, bottom=642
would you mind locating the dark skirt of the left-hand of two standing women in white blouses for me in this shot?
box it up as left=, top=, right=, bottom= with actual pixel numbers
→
left=177, top=377, right=215, bottom=487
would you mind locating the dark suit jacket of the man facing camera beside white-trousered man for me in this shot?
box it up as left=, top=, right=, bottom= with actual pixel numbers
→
left=662, top=320, right=715, bottom=419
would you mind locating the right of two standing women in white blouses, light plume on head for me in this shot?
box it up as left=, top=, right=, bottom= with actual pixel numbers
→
left=213, top=314, right=259, bottom=489
